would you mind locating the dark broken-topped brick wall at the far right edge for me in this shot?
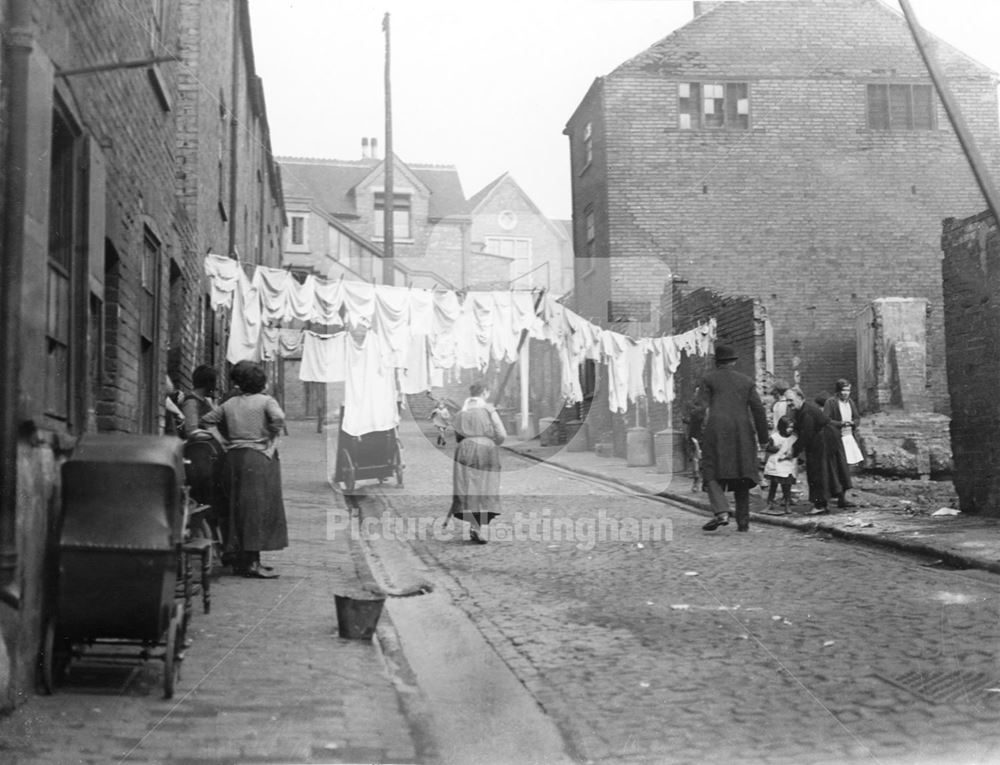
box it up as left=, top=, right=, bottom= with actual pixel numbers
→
left=941, top=213, right=1000, bottom=516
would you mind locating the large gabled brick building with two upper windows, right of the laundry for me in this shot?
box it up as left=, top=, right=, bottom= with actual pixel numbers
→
left=565, top=0, right=1000, bottom=410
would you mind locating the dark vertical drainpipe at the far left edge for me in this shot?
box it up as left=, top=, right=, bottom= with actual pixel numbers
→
left=0, top=0, right=34, bottom=608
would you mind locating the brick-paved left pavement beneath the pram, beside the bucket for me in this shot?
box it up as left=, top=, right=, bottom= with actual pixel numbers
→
left=0, top=421, right=426, bottom=765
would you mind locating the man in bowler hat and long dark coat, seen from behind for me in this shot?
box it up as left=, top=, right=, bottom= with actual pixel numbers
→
left=699, top=345, right=768, bottom=531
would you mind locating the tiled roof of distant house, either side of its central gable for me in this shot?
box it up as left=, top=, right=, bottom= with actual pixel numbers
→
left=278, top=157, right=469, bottom=218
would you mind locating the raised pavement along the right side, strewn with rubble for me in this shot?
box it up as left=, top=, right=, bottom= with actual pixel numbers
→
left=504, top=430, right=1000, bottom=573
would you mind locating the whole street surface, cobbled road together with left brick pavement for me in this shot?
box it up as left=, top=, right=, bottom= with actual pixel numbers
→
left=0, top=422, right=1000, bottom=765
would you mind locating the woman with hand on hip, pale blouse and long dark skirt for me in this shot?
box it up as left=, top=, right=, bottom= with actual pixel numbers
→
left=201, top=364, right=288, bottom=579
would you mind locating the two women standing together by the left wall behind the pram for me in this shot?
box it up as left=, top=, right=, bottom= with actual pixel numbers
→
left=172, top=361, right=288, bottom=579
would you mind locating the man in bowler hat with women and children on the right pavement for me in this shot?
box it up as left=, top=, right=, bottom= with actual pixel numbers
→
left=688, top=345, right=864, bottom=531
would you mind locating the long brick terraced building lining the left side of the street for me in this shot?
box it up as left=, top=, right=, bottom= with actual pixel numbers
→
left=0, top=0, right=284, bottom=708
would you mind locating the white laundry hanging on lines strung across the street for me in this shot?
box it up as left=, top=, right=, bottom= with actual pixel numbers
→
left=205, top=253, right=716, bottom=435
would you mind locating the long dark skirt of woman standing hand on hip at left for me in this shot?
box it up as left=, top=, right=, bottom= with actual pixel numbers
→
left=222, top=449, right=288, bottom=553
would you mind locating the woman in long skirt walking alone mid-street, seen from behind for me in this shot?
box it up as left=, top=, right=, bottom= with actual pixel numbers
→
left=450, top=383, right=507, bottom=544
